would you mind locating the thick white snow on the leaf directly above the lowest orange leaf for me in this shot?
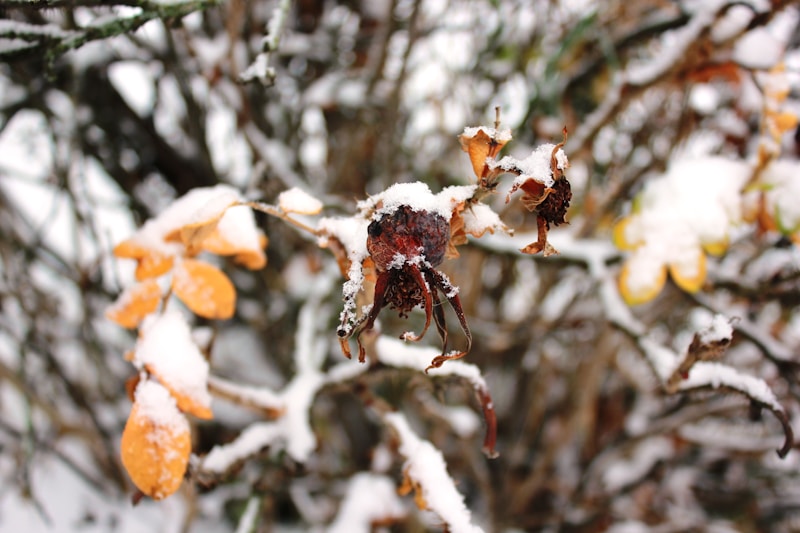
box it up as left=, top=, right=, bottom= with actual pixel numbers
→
left=134, top=309, right=211, bottom=407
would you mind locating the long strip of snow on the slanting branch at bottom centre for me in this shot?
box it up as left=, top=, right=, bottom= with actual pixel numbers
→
left=384, top=413, right=483, bottom=533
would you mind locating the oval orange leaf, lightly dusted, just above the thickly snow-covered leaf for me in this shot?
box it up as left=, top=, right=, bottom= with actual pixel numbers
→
left=172, top=259, right=236, bottom=320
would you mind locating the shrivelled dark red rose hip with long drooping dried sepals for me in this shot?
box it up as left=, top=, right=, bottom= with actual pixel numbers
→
left=340, top=205, right=472, bottom=368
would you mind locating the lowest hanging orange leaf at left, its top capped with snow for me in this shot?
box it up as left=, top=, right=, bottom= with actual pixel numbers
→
left=120, top=381, right=192, bottom=500
